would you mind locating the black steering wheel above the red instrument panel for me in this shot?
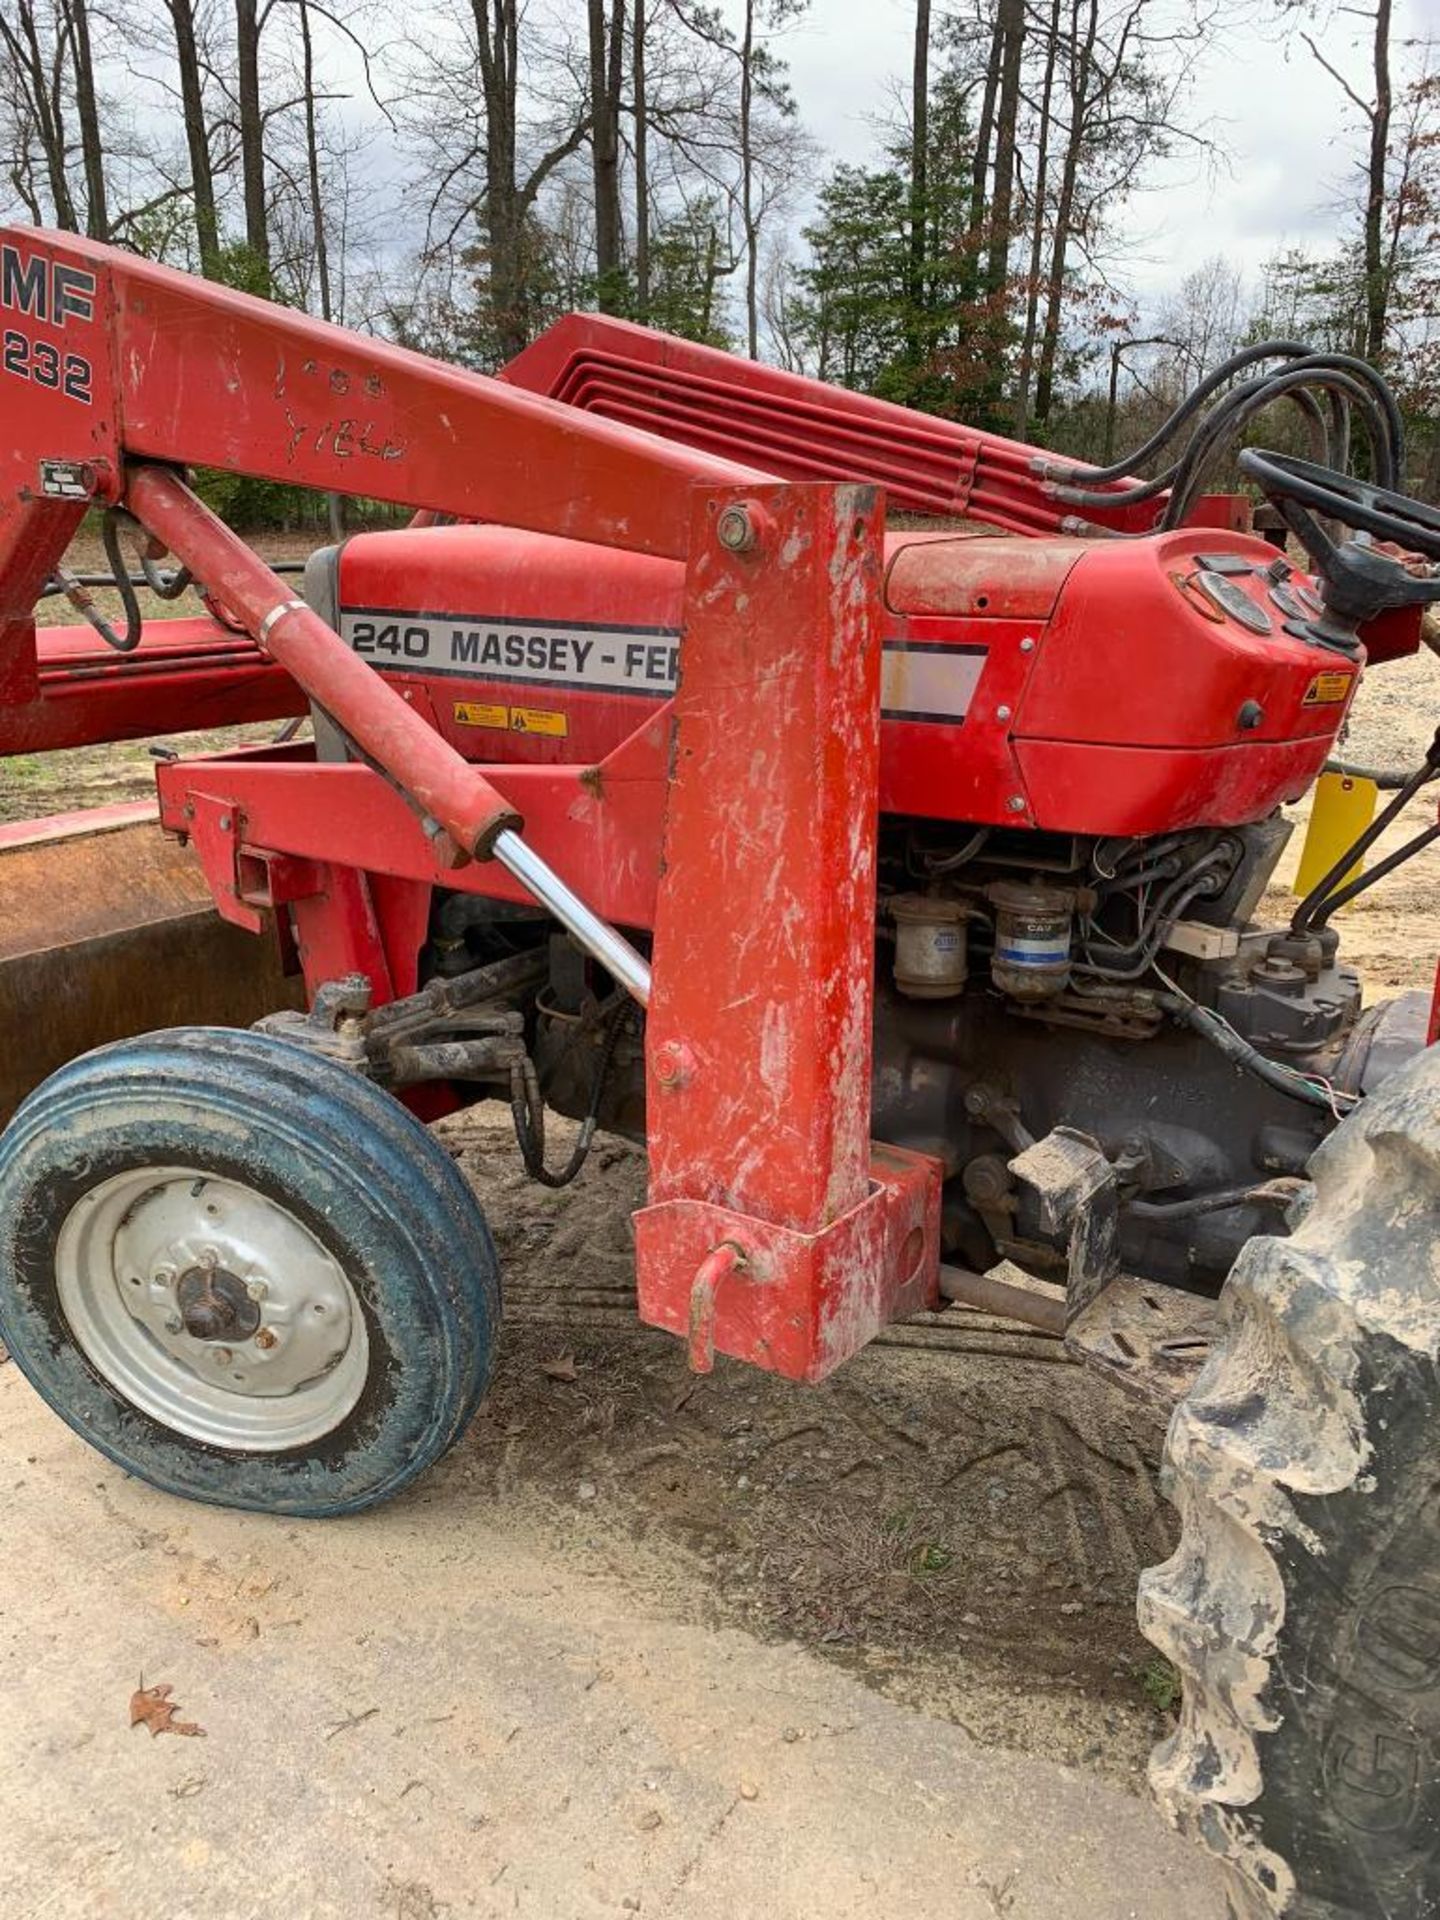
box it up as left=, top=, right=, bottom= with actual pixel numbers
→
left=1240, top=447, right=1440, bottom=653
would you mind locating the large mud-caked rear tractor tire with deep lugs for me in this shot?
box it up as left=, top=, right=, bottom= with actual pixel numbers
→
left=1140, top=1050, right=1440, bottom=1920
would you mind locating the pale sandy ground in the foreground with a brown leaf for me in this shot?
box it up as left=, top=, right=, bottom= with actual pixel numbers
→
left=0, top=1352, right=1223, bottom=1920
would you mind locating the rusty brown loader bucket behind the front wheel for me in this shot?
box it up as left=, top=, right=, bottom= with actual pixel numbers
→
left=0, top=801, right=301, bottom=1125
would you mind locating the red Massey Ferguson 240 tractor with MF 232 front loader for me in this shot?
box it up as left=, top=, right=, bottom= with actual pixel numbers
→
left=0, top=230, right=1440, bottom=1920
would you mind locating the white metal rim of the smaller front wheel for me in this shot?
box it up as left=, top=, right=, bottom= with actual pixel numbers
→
left=56, top=1167, right=371, bottom=1453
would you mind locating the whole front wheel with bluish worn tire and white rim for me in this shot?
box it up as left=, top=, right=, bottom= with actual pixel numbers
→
left=0, top=1029, right=499, bottom=1517
